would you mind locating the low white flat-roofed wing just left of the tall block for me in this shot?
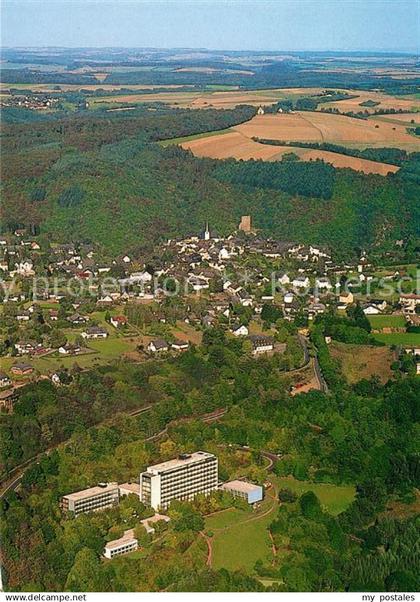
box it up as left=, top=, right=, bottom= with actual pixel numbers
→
left=60, top=483, right=120, bottom=515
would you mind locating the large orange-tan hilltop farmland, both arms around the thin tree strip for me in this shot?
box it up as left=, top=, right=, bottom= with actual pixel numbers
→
left=180, top=112, right=414, bottom=175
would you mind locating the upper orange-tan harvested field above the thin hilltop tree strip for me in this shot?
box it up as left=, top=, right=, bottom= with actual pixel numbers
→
left=235, top=111, right=420, bottom=151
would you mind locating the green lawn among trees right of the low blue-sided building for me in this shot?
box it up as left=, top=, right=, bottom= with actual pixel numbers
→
left=272, top=477, right=356, bottom=516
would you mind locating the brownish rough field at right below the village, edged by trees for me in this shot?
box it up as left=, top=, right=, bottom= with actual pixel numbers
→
left=330, top=335, right=394, bottom=384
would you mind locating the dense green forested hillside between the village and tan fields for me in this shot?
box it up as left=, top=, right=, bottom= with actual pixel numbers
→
left=1, top=106, right=420, bottom=255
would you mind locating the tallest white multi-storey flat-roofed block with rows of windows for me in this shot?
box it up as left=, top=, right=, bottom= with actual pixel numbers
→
left=140, top=451, right=218, bottom=510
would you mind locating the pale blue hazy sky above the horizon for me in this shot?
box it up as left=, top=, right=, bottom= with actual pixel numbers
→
left=1, top=0, right=420, bottom=51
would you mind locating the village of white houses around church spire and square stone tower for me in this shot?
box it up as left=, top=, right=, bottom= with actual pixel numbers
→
left=0, top=216, right=420, bottom=410
